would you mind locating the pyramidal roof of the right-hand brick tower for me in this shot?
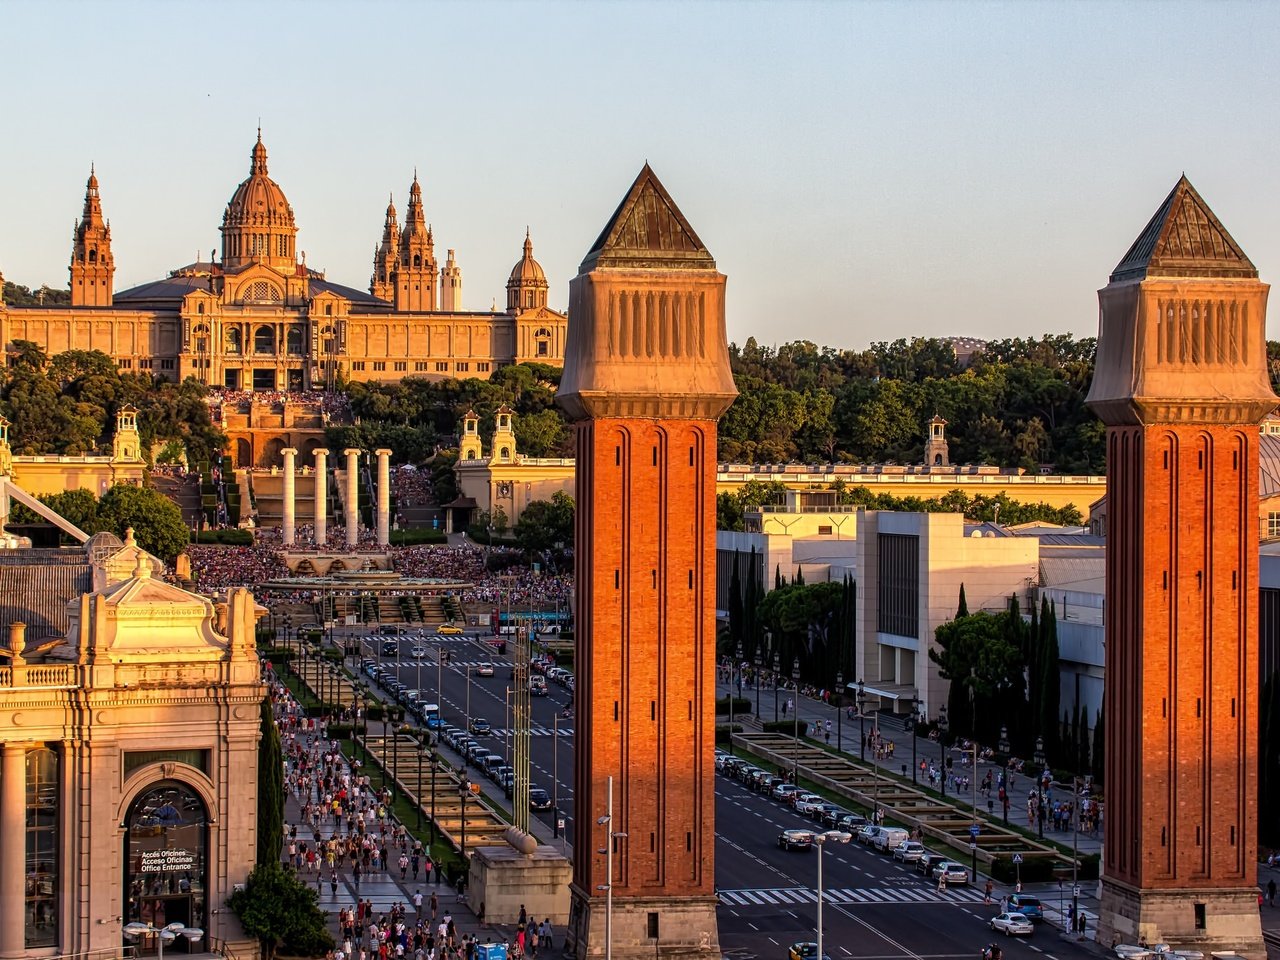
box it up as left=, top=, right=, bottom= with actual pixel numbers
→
left=1111, top=174, right=1258, bottom=283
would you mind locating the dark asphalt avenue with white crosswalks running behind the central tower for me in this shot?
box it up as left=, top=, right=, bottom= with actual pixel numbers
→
left=355, top=635, right=1091, bottom=960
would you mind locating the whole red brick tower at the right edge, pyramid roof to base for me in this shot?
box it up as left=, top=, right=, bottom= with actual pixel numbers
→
left=1088, top=177, right=1277, bottom=957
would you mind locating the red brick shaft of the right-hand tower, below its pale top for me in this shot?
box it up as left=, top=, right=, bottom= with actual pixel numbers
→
left=1105, top=424, right=1258, bottom=888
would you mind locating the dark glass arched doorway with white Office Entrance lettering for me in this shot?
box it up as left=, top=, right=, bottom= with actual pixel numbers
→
left=124, top=780, right=209, bottom=956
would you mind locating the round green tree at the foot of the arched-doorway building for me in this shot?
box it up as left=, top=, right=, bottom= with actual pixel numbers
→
left=227, top=859, right=333, bottom=960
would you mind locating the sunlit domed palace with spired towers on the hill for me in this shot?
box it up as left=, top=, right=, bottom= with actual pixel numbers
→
left=0, top=131, right=566, bottom=390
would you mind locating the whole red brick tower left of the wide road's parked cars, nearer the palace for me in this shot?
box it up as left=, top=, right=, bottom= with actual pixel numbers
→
left=557, top=164, right=737, bottom=960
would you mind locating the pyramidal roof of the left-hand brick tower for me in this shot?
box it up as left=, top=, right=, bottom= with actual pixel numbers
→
left=579, top=163, right=716, bottom=273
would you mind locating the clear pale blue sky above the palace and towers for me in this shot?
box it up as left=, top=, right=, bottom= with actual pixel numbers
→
left=0, top=0, right=1280, bottom=347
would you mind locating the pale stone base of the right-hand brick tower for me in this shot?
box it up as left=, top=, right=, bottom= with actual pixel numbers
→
left=1098, top=877, right=1267, bottom=960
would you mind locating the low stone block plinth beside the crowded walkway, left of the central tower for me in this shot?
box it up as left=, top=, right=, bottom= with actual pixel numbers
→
left=467, top=845, right=572, bottom=928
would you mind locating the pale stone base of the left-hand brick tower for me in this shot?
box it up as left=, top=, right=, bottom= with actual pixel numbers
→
left=564, top=886, right=721, bottom=960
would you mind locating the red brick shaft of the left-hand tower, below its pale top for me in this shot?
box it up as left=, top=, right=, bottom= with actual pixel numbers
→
left=573, top=419, right=716, bottom=897
